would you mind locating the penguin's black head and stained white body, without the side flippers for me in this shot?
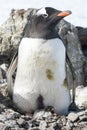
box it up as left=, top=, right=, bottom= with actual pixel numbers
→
left=7, top=7, right=71, bottom=114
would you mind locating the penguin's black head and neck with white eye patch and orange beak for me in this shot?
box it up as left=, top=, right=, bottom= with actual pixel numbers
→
left=27, top=7, right=71, bottom=39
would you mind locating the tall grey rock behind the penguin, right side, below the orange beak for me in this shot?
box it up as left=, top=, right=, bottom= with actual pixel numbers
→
left=57, top=20, right=85, bottom=88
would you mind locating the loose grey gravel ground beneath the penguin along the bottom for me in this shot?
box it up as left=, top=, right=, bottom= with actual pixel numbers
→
left=0, top=83, right=87, bottom=130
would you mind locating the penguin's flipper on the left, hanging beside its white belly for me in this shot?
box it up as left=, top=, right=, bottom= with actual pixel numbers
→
left=7, top=53, right=18, bottom=96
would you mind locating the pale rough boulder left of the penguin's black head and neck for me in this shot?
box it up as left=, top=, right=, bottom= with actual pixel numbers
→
left=0, top=9, right=32, bottom=62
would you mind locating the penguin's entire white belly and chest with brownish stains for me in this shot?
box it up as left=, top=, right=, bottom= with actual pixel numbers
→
left=13, top=38, right=70, bottom=114
